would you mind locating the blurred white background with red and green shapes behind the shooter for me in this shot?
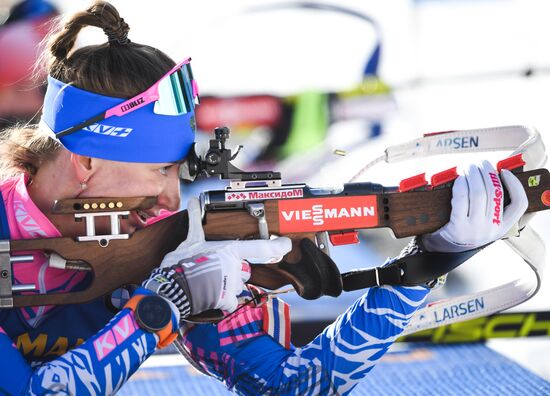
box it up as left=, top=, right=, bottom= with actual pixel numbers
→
left=0, top=0, right=550, bottom=386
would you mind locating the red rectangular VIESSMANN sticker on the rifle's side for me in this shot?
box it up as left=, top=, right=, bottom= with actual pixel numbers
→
left=278, top=195, right=378, bottom=233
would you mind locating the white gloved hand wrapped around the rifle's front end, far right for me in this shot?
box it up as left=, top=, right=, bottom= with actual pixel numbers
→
left=421, top=161, right=528, bottom=253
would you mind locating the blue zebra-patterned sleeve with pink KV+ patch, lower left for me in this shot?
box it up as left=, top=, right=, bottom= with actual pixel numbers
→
left=0, top=290, right=172, bottom=395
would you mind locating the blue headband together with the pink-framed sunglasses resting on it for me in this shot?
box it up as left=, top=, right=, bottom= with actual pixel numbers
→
left=40, top=58, right=199, bottom=163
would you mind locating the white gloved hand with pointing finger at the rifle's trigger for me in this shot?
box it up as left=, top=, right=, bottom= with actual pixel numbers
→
left=143, top=198, right=292, bottom=319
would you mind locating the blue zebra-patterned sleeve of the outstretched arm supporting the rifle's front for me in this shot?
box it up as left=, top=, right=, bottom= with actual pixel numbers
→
left=181, top=237, right=436, bottom=395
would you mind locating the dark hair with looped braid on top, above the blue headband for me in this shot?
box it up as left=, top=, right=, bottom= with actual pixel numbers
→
left=48, top=1, right=175, bottom=98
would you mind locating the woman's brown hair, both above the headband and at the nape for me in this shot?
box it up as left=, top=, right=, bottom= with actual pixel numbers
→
left=0, top=1, right=175, bottom=179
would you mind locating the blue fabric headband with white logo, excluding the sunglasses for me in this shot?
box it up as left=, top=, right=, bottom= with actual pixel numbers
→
left=41, top=76, right=195, bottom=163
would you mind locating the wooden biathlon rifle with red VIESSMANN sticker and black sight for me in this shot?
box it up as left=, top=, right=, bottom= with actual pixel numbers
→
left=0, top=127, right=550, bottom=320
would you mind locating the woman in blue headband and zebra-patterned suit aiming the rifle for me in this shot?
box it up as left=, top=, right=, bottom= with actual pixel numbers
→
left=0, top=2, right=527, bottom=395
